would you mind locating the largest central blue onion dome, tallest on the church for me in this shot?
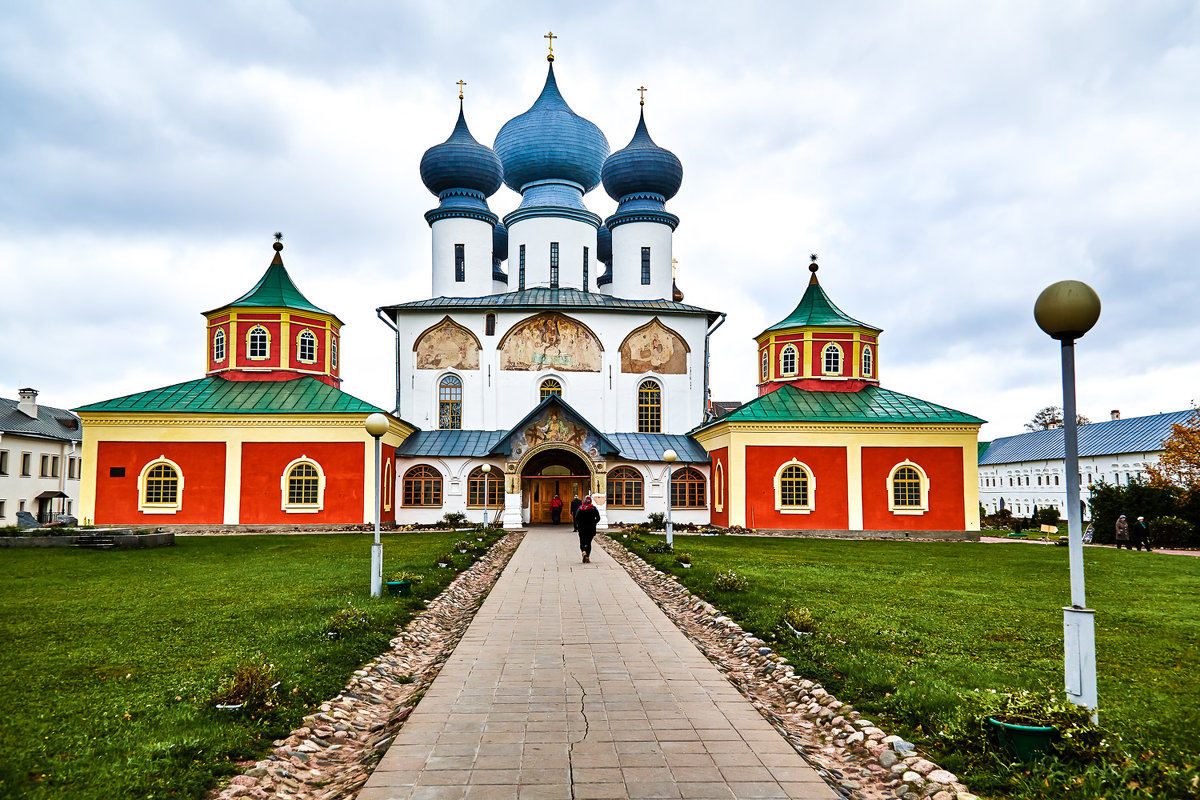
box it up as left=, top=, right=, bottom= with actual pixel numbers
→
left=492, top=64, right=608, bottom=192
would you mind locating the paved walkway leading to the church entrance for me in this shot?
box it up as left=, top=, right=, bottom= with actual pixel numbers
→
left=359, top=527, right=838, bottom=800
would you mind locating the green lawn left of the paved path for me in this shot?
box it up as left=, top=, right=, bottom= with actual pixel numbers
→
left=0, top=531, right=501, bottom=800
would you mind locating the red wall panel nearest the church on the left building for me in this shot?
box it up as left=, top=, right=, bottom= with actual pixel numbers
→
left=240, top=441, right=366, bottom=525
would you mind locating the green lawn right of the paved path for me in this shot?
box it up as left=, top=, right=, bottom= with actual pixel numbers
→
left=618, top=536, right=1200, bottom=800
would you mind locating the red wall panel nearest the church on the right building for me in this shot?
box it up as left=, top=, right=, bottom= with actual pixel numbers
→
left=745, top=446, right=850, bottom=530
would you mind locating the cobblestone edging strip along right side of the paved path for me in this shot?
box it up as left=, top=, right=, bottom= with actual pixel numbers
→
left=596, top=535, right=977, bottom=800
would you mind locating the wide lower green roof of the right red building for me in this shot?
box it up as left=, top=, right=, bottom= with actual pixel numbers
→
left=696, top=384, right=984, bottom=431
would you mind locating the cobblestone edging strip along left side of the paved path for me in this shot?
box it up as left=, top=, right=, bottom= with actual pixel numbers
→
left=210, top=531, right=524, bottom=800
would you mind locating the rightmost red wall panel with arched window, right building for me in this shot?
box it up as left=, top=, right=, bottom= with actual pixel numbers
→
left=863, top=447, right=966, bottom=530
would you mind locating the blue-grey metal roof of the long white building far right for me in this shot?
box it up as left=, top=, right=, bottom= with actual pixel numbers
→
left=979, top=409, right=1194, bottom=464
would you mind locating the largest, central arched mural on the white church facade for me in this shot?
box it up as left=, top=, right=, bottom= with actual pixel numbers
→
left=499, top=312, right=604, bottom=372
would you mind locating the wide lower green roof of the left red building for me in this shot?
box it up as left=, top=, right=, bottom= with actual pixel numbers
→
left=76, top=375, right=383, bottom=414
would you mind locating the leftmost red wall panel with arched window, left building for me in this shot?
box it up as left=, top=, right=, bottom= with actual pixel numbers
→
left=92, top=441, right=226, bottom=525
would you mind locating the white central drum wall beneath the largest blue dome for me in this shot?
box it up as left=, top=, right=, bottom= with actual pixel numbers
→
left=508, top=217, right=604, bottom=291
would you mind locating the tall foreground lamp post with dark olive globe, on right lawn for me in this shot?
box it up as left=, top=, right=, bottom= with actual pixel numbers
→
left=1033, top=281, right=1100, bottom=720
